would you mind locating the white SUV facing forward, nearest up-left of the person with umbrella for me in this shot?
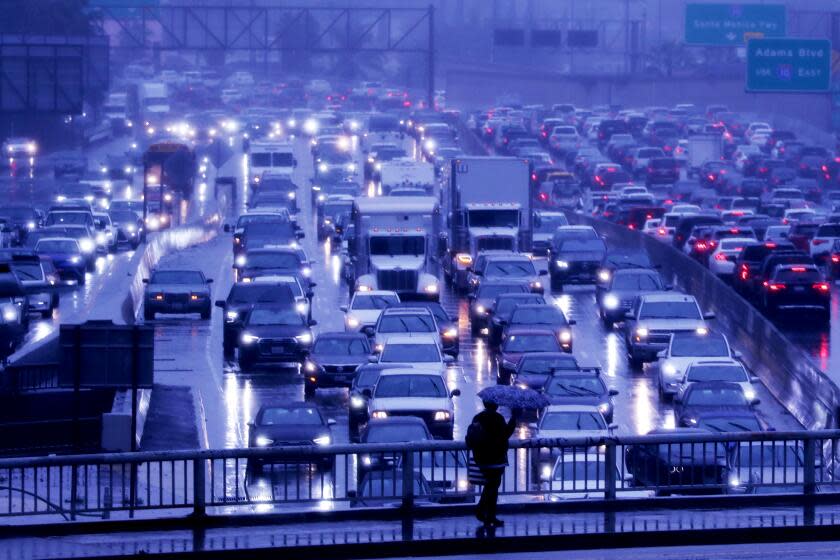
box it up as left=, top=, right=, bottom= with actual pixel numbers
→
left=368, top=368, right=461, bottom=439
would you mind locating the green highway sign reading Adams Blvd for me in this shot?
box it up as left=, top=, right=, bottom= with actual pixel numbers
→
left=747, top=39, right=831, bottom=92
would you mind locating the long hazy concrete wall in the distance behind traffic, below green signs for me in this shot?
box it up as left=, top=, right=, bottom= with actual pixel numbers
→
left=440, top=66, right=831, bottom=130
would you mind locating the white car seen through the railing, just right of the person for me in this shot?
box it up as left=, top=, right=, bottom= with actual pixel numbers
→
left=540, top=451, right=655, bottom=501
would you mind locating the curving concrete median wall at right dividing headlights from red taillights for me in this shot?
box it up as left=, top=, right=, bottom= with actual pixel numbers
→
left=568, top=213, right=840, bottom=429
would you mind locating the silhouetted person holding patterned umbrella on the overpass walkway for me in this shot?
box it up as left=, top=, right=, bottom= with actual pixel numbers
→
left=466, top=386, right=545, bottom=528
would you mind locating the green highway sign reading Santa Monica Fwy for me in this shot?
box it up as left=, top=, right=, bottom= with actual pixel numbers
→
left=685, top=4, right=786, bottom=46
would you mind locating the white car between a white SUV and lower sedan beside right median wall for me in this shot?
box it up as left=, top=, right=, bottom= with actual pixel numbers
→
left=655, top=332, right=741, bottom=400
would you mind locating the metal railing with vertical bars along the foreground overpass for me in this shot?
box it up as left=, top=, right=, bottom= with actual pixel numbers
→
left=0, top=430, right=840, bottom=523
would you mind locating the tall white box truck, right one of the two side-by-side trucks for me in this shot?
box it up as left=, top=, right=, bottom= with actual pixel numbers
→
left=441, top=156, right=533, bottom=291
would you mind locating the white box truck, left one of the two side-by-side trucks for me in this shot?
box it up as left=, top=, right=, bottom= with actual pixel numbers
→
left=351, top=196, right=441, bottom=301
